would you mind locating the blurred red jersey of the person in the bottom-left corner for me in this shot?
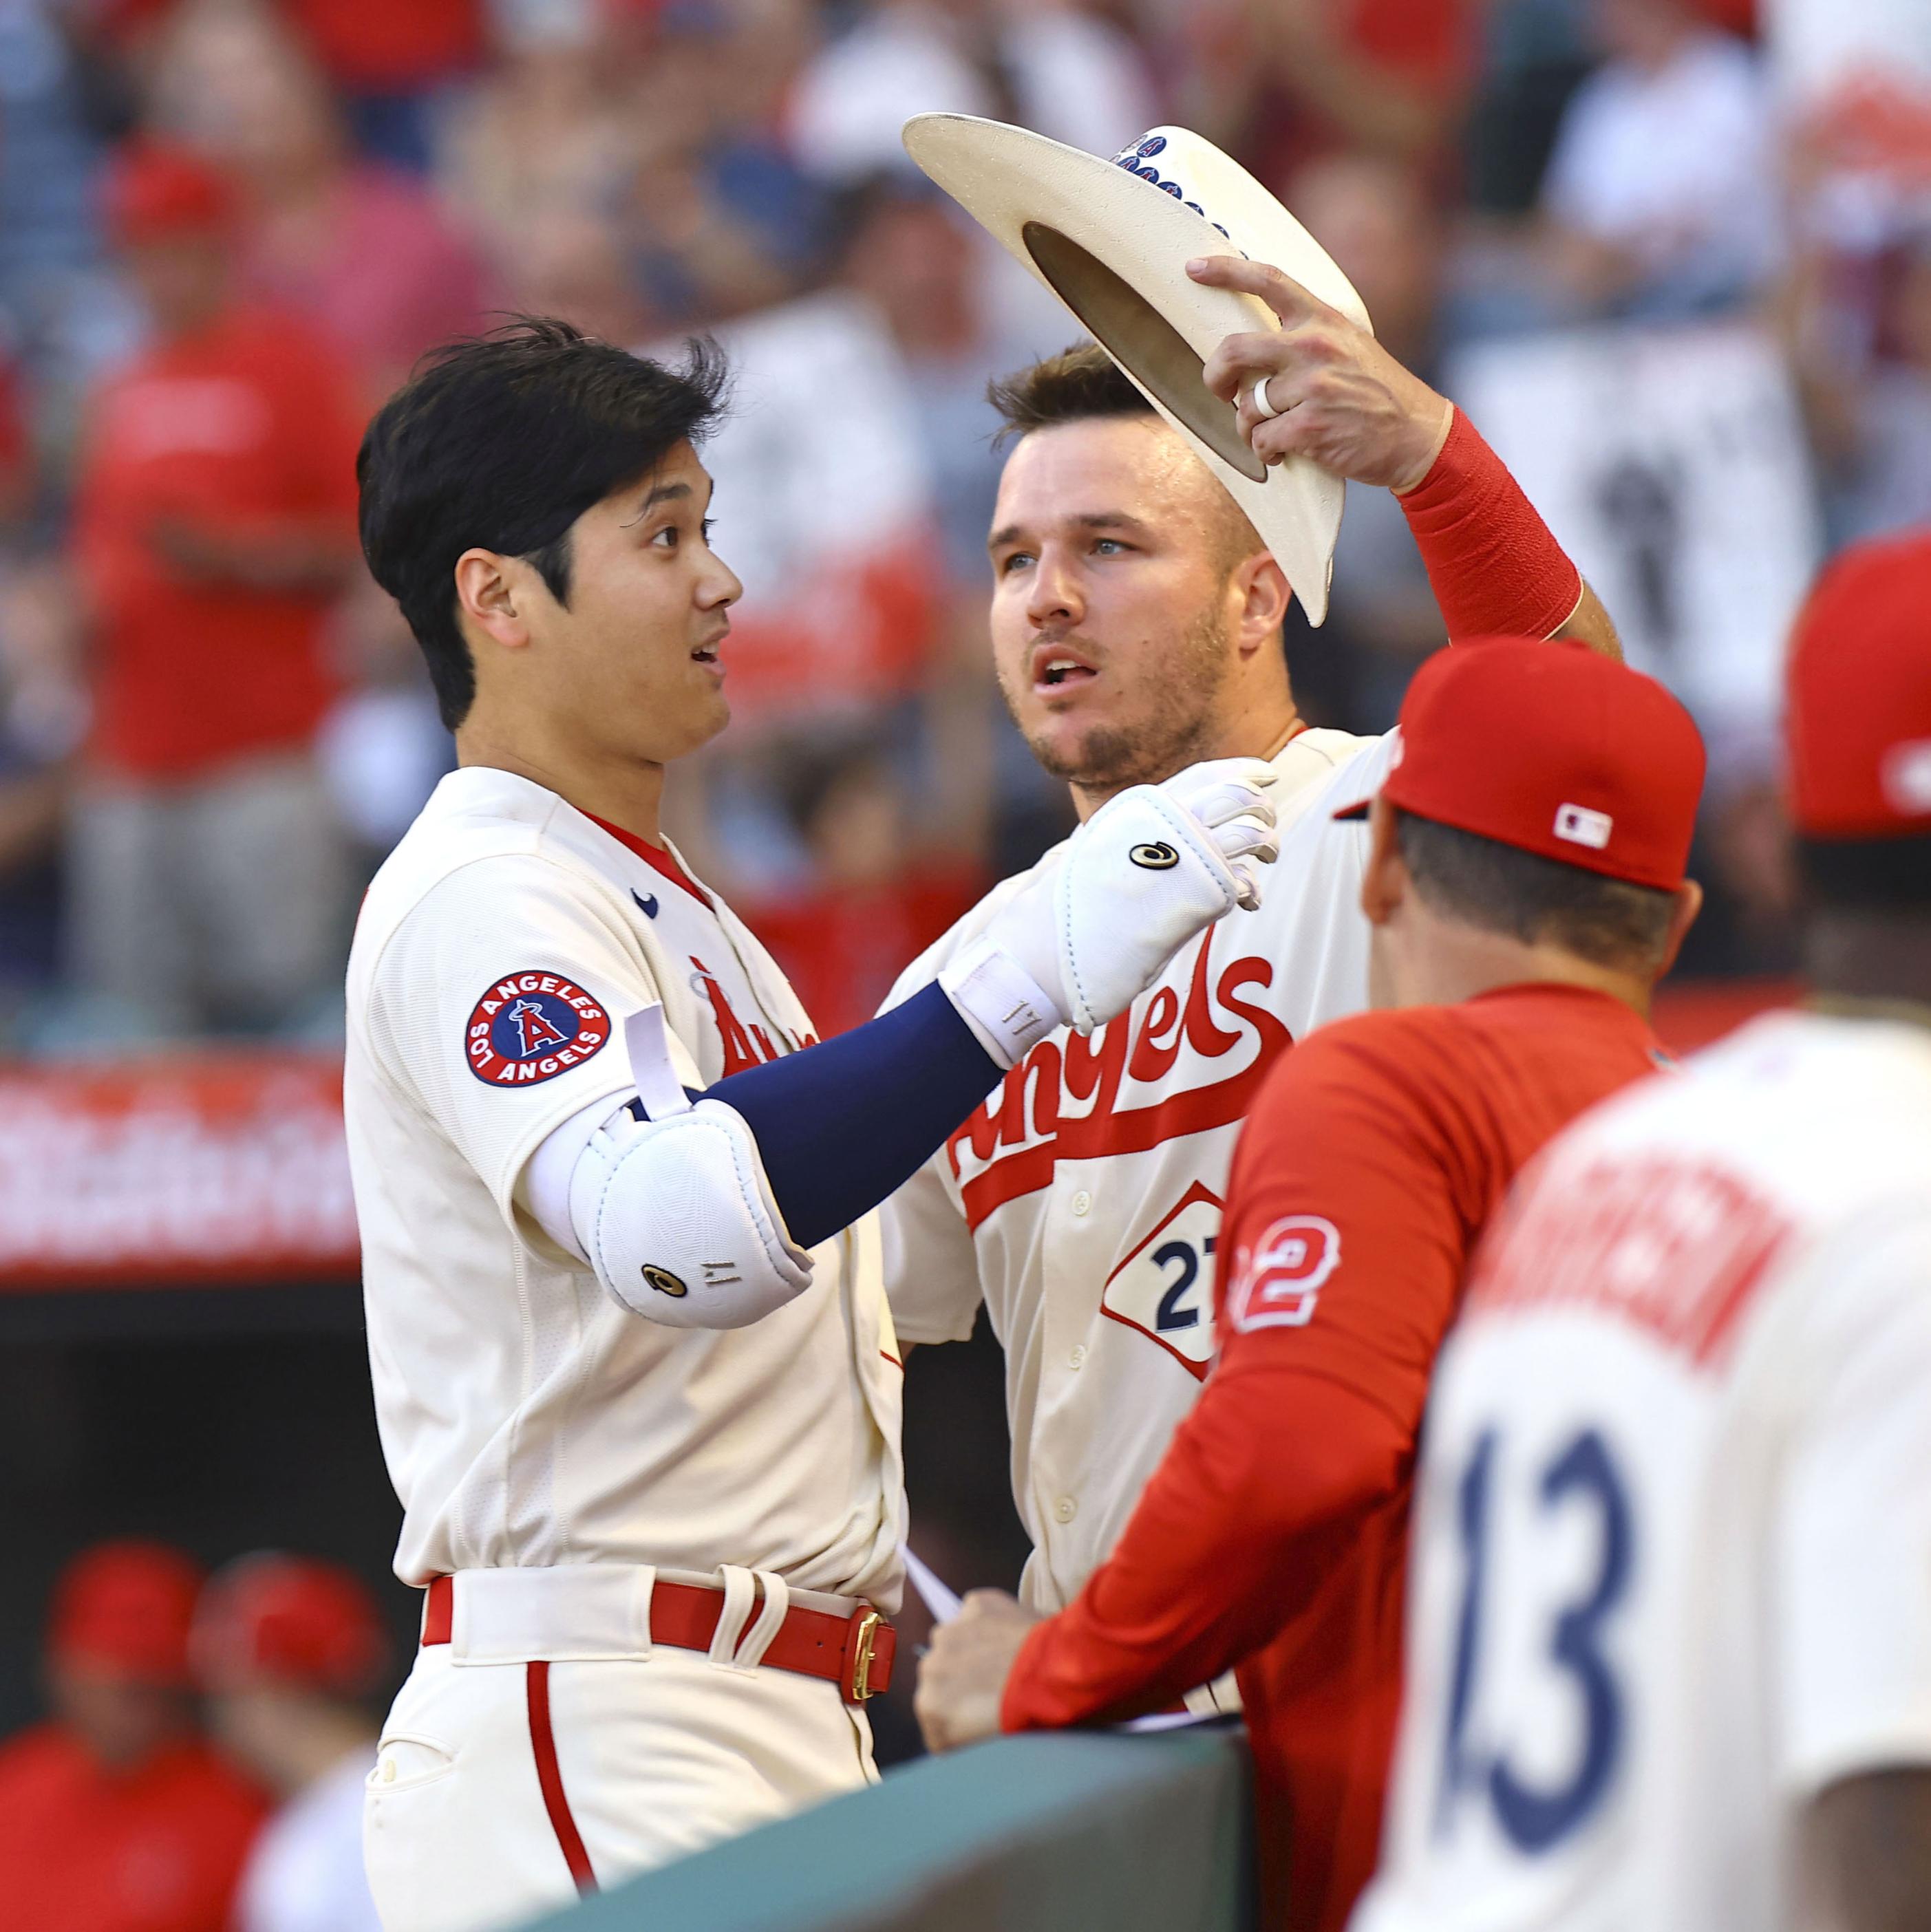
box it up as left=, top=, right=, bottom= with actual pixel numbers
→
left=0, top=1724, right=268, bottom=1932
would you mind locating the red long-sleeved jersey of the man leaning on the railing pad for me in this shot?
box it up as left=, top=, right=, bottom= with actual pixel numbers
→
left=1001, top=981, right=1663, bottom=1932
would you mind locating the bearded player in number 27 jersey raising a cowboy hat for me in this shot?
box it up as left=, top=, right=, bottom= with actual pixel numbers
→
left=884, top=257, right=1616, bottom=1653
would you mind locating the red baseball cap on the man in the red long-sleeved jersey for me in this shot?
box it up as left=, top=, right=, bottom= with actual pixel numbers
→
left=1336, top=638, right=1703, bottom=892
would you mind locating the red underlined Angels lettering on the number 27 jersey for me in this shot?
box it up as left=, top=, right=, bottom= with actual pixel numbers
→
left=947, top=927, right=1293, bottom=1229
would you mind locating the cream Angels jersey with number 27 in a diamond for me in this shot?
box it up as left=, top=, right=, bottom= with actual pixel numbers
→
left=882, top=730, right=1394, bottom=1611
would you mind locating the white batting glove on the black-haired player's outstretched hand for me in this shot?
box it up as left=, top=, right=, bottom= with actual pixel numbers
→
left=939, top=758, right=1278, bottom=1066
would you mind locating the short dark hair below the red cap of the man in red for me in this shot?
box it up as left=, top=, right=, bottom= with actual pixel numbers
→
left=1396, top=811, right=1676, bottom=972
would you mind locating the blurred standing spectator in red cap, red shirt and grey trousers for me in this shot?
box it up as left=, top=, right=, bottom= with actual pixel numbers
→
left=70, top=147, right=361, bottom=1030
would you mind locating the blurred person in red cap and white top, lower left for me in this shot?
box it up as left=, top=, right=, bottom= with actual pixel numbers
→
left=193, top=1552, right=390, bottom=1932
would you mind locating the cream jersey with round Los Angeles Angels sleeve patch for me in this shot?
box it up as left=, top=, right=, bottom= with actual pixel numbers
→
left=344, top=767, right=903, bottom=1609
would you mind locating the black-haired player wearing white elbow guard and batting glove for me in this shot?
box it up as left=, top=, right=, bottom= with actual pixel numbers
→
left=346, top=321, right=1274, bottom=1932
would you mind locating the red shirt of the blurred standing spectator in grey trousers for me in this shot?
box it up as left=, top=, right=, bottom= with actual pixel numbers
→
left=76, top=309, right=361, bottom=779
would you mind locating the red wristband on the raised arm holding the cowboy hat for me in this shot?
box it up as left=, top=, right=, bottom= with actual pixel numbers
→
left=1396, top=409, right=1583, bottom=641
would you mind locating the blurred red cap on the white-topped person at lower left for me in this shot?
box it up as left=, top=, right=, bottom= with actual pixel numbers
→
left=193, top=1549, right=389, bottom=1698
